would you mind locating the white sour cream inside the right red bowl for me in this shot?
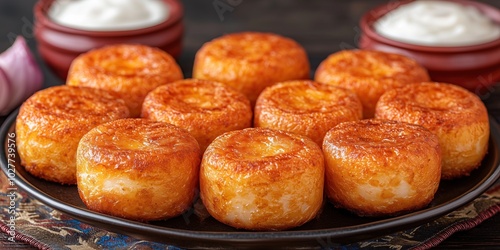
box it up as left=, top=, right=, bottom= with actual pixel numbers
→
left=374, top=0, right=500, bottom=47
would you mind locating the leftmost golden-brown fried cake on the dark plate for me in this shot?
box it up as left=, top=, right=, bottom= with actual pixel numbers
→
left=16, top=86, right=129, bottom=184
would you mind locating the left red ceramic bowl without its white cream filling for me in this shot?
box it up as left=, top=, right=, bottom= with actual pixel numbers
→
left=34, top=0, right=184, bottom=79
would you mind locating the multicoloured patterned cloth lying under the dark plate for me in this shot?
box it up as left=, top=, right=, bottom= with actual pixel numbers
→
left=0, top=85, right=500, bottom=249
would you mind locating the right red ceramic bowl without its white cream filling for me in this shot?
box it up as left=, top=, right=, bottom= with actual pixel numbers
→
left=359, top=0, right=500, bottom=93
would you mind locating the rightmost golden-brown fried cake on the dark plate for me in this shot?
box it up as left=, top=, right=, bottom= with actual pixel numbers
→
left=375, top=82, right=490, bottom=179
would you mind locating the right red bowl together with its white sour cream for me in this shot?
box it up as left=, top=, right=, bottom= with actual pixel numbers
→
left=359, top=0, right=500, bottom=94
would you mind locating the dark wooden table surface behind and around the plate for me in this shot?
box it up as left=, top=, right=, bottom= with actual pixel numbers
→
left=0, top=0, right=500, bottom=249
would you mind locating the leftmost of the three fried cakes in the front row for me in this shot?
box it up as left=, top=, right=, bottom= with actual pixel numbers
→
left=77, top=118, right=201, bottom=221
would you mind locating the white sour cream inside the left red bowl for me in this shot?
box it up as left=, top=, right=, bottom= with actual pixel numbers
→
left=48, top=0, right=170, bottom=31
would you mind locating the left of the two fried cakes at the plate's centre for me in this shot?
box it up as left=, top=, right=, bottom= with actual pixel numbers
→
left=141, top=79, right=252, bottom=151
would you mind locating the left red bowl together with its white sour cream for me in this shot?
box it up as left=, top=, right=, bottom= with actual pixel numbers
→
left=34, top=0, right=184, bottom=79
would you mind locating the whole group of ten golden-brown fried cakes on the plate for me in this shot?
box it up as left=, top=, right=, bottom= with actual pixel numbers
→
left=16, top=32, right=489, bottom=230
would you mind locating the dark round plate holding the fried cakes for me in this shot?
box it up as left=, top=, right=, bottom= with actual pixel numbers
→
left=0, top=112, right=500, bottom=248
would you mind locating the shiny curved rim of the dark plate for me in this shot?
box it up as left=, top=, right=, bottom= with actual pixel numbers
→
left=0, top=108, right=500, bottom=246
